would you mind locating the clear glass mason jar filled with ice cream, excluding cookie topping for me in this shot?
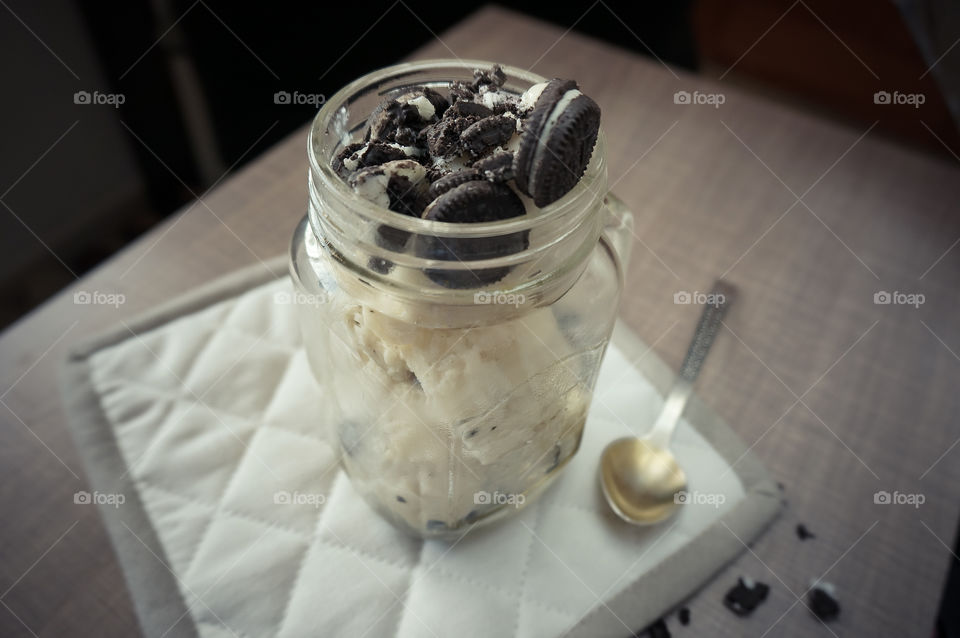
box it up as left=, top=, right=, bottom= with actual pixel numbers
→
left=291, top=60, right=632, bottom=538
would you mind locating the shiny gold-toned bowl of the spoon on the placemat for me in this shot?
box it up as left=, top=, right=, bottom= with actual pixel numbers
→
left=600, top=437, right=687, bottom=525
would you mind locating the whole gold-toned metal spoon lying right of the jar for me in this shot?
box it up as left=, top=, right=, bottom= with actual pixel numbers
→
left=600, top=280, right=735, bottom=525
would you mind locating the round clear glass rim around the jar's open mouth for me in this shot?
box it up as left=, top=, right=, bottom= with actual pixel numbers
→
left=307, top=58, right=605, bottom=238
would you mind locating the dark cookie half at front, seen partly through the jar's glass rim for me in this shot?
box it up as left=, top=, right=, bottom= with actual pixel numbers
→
left=415, top=180, right=530, bottom=289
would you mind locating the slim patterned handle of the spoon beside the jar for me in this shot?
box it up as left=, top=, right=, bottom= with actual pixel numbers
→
left=644, top=280, right=736, bottom=449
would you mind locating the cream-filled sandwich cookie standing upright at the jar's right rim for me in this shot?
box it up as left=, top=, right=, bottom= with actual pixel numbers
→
left=514, top=79, right=600, bottom=207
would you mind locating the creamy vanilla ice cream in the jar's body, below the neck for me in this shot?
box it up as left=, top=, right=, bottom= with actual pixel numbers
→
left=328, top=305, right=600, bottom=531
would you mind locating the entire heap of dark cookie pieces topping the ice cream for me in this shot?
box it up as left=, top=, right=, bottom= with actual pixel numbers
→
left=331, top=65, right=600, bottom=288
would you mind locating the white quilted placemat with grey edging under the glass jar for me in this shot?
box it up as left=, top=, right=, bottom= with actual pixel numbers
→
left=58, top=260, right=778, bottom=638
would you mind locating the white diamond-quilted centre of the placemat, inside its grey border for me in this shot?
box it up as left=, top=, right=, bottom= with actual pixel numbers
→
left=91, top=280, right=743, bottom=638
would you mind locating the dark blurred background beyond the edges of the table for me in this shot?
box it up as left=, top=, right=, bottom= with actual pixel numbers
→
left=0, top=0, right=960, bottom=636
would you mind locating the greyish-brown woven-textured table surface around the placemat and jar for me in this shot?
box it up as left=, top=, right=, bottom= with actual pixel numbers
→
left=0, top=6, right=960, bottom=636
